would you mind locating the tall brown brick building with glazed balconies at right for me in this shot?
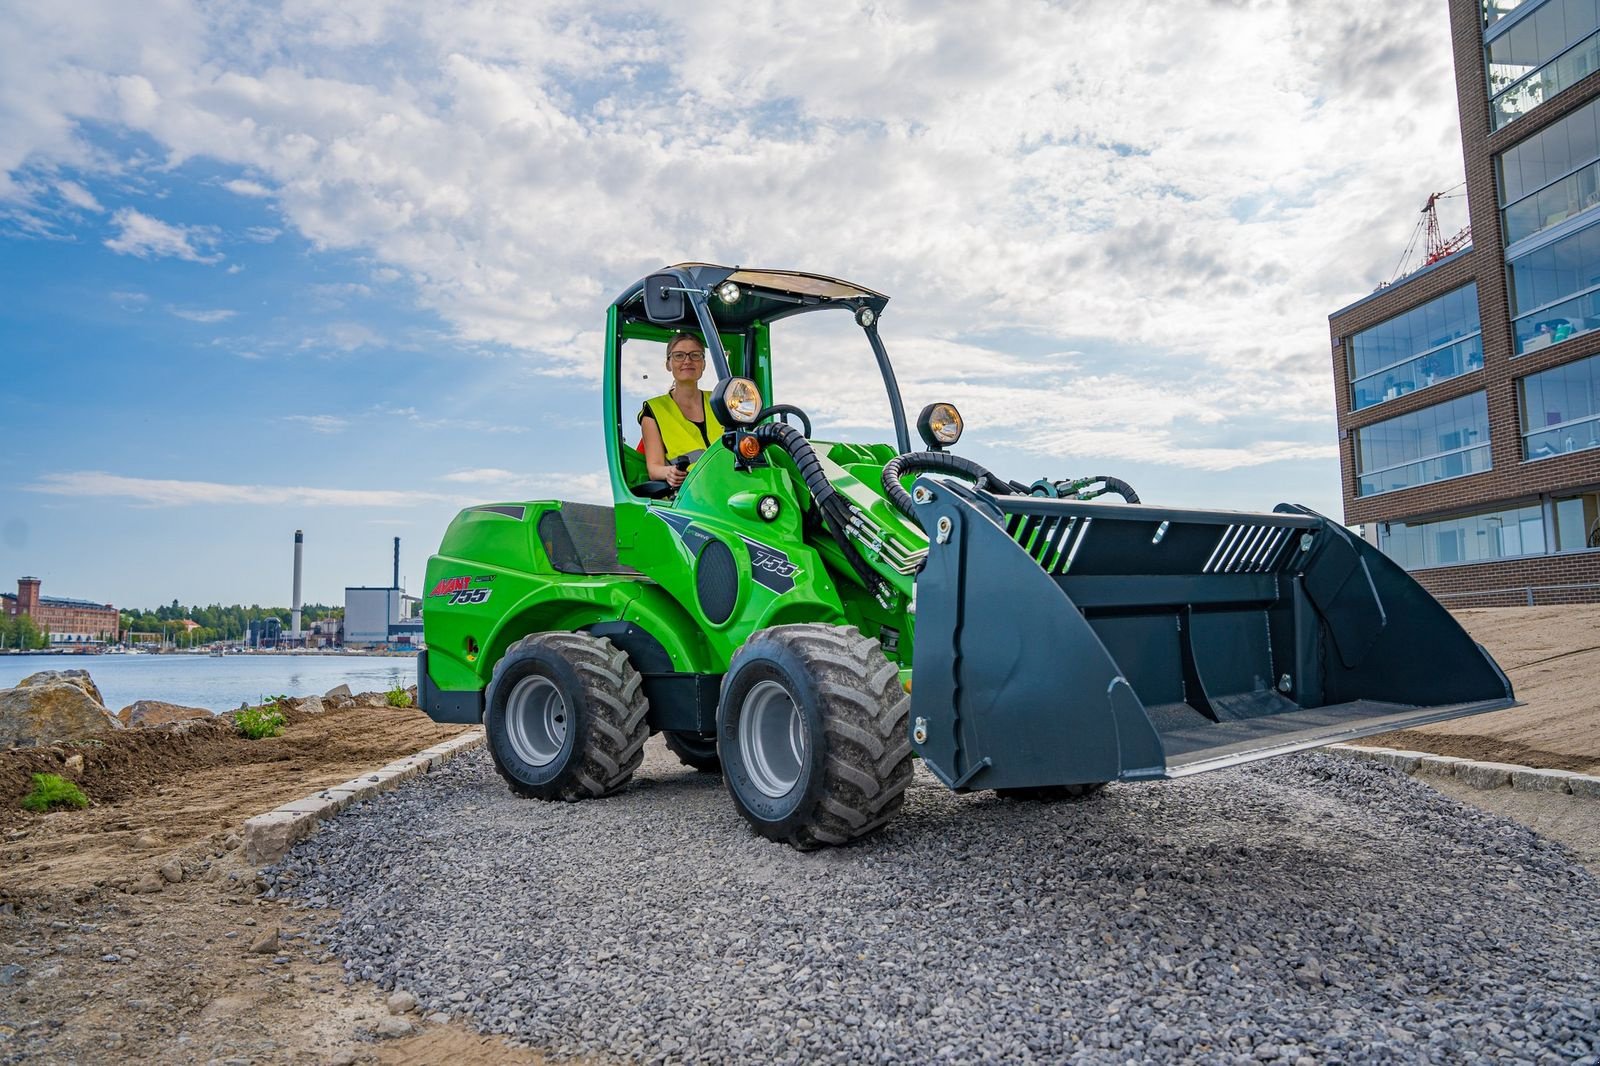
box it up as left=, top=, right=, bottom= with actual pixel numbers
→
left=1328, top=0, right=1600, bottom=607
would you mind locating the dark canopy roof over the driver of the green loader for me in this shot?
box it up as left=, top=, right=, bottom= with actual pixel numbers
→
left=616, top=262, right=890, bottom=330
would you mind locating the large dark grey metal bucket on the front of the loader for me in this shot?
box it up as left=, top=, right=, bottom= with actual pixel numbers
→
left=910, top=477, right=1514, bottom=791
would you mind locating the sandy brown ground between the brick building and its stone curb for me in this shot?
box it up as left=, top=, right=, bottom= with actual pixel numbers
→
left=1360, top=603, right=1600, bottom=773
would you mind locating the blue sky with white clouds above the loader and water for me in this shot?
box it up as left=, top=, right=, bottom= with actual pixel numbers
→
left=0, top=0, right=1461, bottom=607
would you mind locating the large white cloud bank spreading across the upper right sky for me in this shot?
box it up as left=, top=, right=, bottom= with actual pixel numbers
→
left=0, top=0, right=1461, bottom=473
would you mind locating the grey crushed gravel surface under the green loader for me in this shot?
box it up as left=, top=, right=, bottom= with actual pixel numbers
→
left=269, top=741, right=1600, bottom=1063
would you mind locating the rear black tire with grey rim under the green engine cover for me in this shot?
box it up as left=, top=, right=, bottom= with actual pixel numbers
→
left=483, top=632, right=650, bottom=800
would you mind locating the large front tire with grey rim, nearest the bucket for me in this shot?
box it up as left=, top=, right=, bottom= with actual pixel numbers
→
left=717, top=623, right=912, bottom=850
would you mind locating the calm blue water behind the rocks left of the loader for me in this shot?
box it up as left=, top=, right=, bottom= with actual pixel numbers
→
left=0, top=653, right=416, bottom=714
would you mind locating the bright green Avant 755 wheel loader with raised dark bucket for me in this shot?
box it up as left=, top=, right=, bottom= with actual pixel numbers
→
left=418, top=264, right=1512, bottom=848
